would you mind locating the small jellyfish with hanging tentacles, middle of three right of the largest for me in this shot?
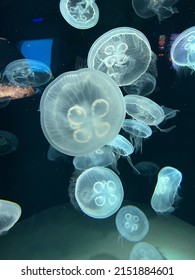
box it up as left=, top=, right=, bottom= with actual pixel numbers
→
left=122, top=119, right=152, bottom=153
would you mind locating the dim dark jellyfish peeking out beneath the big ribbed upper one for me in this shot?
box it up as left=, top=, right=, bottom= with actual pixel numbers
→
left=123, top=72, right=156, bottom=96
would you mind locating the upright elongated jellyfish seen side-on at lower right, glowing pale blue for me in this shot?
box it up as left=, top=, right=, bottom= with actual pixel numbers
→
left=151, top=166, right=182, bottom=213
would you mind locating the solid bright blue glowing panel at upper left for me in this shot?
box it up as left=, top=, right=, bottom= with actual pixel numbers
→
left=18, top=39, right=53, bottom=67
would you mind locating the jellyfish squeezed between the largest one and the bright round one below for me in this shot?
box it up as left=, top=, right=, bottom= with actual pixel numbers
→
left=73, top=147, right=118, bottom=173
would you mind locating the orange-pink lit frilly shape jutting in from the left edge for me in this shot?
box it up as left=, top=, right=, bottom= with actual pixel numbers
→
left=0, top=84, right=40, bottom=103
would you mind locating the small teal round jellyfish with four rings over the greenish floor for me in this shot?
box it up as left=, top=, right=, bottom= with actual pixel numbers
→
left=115, top=205, right=149, bottom=242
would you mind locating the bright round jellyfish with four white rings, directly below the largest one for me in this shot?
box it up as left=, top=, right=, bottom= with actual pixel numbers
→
left=75, top=167, right=124, bottom=219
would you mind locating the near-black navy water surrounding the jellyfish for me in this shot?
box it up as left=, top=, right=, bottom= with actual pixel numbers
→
left=0, top=0, right=195, bottom=225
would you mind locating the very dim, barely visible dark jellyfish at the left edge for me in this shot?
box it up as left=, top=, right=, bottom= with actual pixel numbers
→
left=0, top=130, right=18, bottom=156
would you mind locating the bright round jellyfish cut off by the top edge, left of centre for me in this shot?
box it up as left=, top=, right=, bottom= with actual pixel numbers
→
left=60, top=0, right=99, bottom=29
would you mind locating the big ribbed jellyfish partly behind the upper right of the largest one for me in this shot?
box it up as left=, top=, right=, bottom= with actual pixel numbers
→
left=87, top=27, right=152, bottom=86
